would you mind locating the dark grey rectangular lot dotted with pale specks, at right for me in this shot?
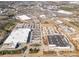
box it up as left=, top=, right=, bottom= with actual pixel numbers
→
left=48, top=35, right=69, bottom=47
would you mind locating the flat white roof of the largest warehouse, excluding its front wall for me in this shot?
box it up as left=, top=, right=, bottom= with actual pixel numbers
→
left=4, top=28, right=30, bottom=44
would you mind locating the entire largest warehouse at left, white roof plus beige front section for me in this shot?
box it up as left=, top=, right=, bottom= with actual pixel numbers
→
left=2, top=28, right=31, bottom=49
